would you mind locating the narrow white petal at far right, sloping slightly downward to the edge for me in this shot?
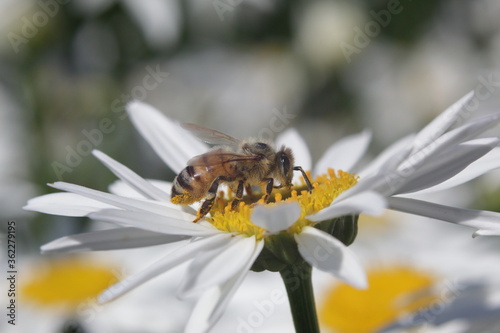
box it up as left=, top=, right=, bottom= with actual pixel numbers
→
left=387, top=197, right=500, bottom=236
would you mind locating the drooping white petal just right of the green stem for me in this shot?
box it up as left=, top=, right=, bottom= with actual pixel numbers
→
left=295, top=227, right=368, bottom=289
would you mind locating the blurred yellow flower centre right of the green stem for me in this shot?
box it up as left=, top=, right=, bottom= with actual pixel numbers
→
left=319, top=267, right=437, bottom=333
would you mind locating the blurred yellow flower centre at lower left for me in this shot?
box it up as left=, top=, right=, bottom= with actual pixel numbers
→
left=20, top=258, right=118, bottom=311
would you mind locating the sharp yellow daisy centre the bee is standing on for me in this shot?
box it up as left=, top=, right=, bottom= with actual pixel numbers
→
left=208, top=169, right=357, bottom=239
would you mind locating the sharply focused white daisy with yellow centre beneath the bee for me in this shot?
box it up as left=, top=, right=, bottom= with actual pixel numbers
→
left=25, top=89, right=500, bottom=332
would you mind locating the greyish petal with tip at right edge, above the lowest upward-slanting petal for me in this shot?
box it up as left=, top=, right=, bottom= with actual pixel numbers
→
left=394, top=138, right=500, bottom=194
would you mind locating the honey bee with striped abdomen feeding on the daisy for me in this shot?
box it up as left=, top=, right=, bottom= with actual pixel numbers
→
left=171, top=124, right=312, bottom=222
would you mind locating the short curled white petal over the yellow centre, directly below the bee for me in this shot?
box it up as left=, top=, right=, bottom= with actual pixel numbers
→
left=250, top=202, right=301, bottom=234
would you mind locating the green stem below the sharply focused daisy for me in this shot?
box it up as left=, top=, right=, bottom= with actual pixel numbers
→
left=280, top=262, right=319, bottom=333
